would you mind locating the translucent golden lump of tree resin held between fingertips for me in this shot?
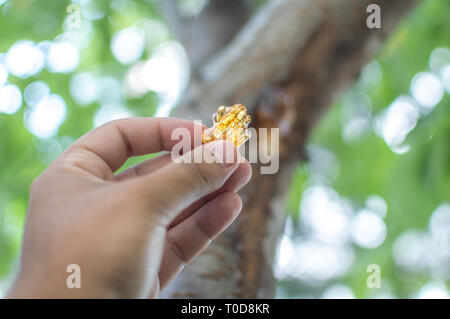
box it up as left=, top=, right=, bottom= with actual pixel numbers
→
left=202, top=104, right=251, bottom=147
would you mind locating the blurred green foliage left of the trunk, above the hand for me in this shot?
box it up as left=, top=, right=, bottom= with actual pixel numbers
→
left=0, top=0, right=167, bottom=283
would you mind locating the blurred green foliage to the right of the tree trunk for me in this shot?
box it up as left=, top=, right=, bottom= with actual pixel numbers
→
left=281, top=1, right=450, bottom=298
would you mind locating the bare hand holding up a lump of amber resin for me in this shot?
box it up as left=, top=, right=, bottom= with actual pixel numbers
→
left=7, top=118, right=251, bottom=298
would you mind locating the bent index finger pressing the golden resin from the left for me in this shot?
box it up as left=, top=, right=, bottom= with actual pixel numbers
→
left=68, top=117, right=204, bottom=172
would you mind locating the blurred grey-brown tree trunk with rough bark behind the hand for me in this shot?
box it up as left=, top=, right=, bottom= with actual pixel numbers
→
left=162, top=0, right=416, bottom=298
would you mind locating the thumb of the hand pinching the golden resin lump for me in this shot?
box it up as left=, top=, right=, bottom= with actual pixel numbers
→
left=132, top=140, right=242, bottom=224
